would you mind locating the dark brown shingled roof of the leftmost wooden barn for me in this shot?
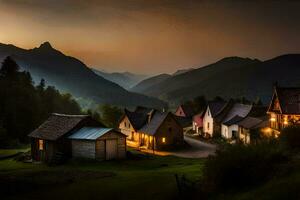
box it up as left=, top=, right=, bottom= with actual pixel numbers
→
left=28, top=113, right=89, bottom=140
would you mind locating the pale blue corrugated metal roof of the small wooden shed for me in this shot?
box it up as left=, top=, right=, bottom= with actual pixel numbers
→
left=68, top=127, right=123, bottom=140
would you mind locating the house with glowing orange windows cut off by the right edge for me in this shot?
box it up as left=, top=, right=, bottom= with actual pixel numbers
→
left=268, top=85, right=300, bottom=134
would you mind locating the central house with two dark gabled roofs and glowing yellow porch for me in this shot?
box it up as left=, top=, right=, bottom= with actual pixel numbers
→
left=119, top=107, right=184, bottom=150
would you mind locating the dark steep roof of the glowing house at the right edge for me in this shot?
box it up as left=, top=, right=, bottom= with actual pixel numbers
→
left=275, top=87, right=300, bottom=114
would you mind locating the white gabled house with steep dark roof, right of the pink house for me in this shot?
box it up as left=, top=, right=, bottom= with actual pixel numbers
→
left=203, top=101, right=232, bottom=137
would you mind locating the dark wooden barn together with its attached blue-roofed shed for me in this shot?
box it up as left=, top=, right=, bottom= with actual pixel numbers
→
left=28, top=113, right=126, bottom=162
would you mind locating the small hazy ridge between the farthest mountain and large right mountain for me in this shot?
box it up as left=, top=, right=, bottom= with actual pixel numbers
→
left=130, top=74, right=172, bottom=93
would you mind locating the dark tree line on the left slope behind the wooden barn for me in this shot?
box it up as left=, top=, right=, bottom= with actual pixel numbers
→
left=0, top=57, right=122, bottom=147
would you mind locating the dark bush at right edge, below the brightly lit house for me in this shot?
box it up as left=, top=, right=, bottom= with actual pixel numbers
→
left=279, top=125, right=300, bottom=151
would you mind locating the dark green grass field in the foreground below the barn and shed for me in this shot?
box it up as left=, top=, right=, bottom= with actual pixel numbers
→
left=0, top=149, right=204, bottom=200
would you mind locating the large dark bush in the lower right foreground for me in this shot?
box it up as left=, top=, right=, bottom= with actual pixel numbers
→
left=203, top=142, right=288, bottom=192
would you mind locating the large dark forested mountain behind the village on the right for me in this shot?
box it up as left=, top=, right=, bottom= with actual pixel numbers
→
left=134, top=54, right=300, bottom=103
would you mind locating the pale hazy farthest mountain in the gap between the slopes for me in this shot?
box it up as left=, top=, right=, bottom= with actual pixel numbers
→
left=92, top=69, right=147, bottom=89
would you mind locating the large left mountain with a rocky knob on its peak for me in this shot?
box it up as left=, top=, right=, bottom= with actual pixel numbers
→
left=0, top=42, right=165, bottom=108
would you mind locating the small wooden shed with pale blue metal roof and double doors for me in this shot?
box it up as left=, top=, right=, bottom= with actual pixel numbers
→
left=68, top=127, right=126, bottom=160
